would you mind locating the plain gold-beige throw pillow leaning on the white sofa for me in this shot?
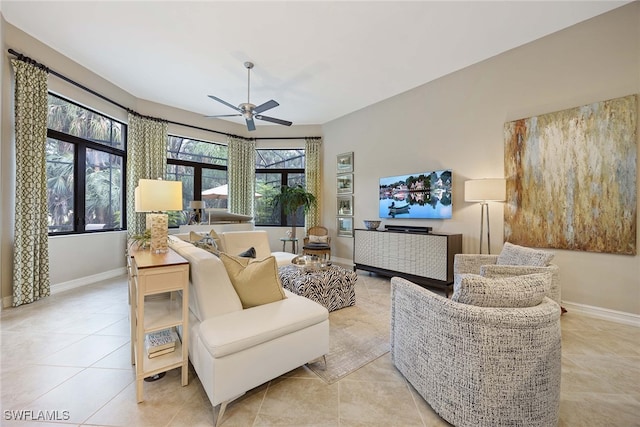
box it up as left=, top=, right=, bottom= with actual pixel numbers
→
left=220, top=252, right=286, bottom=308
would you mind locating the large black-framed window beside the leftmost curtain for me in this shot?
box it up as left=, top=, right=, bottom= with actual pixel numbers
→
left=46, top=94, right=126, bottom=234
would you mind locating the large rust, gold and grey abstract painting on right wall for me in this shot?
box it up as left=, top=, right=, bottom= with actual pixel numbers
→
left=504, top=95, right=638, bottom=255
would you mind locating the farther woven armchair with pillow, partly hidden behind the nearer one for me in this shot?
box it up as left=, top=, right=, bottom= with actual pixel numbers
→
left=453, top=242, right=564, bottom=311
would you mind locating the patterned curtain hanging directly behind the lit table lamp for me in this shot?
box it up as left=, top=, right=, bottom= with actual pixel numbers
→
left=127, top=113, right=167, bottom=235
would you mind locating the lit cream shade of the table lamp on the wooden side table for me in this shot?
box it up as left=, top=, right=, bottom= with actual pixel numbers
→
left=135, top=179, right=182, bottom=212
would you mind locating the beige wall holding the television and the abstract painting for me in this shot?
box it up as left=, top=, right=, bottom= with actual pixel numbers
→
left=323, top=2, right=640, bottom=314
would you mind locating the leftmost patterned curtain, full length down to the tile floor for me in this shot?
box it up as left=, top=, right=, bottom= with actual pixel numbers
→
left=11, top=59, right=51, bottom=307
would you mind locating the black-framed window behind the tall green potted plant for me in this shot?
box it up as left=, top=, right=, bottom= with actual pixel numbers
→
left=255, top=149, right=305, bottom=227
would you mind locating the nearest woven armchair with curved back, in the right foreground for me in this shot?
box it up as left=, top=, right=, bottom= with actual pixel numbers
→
left=391, top=277, right=561, bottom=427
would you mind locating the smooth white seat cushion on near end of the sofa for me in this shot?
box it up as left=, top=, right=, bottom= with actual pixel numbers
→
left=199, top=291, right=329, bottom=358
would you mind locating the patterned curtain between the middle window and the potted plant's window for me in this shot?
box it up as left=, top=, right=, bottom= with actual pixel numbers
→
left=227, top=137, right=256, bottom=216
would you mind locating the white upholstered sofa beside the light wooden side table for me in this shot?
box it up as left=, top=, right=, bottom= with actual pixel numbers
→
left=170, top=236, right=329, bottom=425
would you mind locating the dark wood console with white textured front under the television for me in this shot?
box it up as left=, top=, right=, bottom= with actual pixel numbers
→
left=353, top=229, right=462, bottom=294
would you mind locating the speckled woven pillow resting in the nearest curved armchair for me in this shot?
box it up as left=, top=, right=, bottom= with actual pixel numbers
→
left=451, top=273, right=551, bottom=308
